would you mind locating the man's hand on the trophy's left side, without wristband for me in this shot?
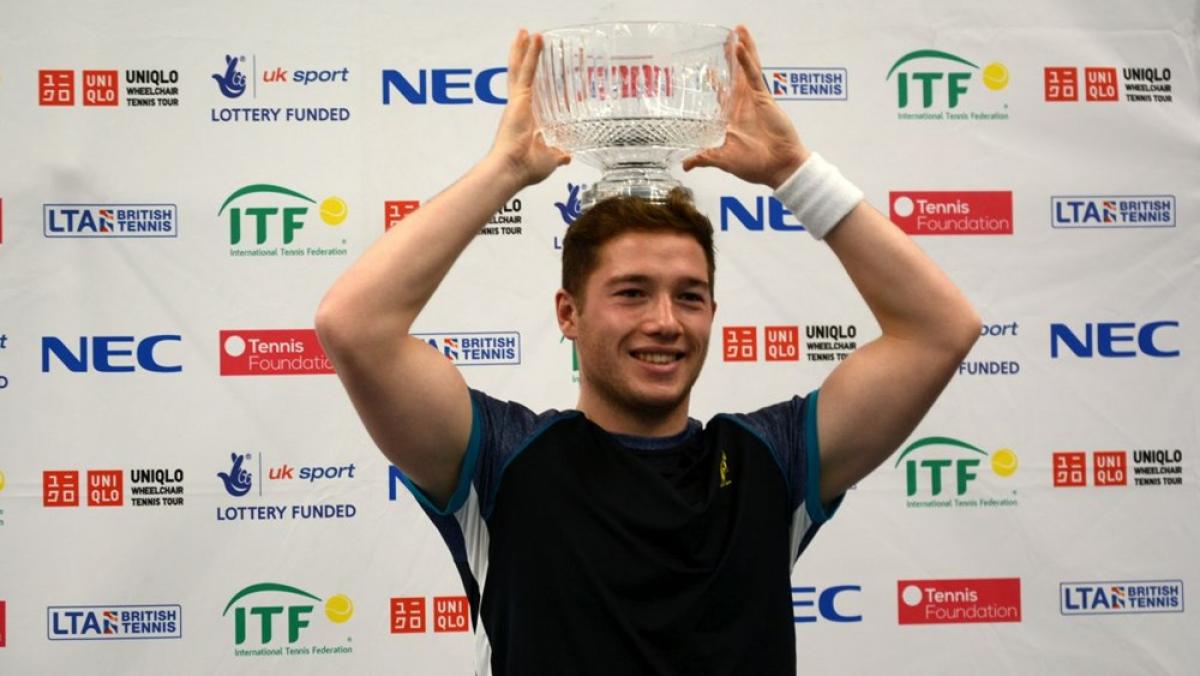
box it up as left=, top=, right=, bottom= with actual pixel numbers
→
left=488, top=29, right=571, bottom=187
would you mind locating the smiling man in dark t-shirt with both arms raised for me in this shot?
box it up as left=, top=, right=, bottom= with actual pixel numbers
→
left=317, top=26, right=979, bottom=676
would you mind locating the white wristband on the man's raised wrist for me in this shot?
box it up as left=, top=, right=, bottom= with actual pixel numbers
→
left=775, top=152, right=863, bottom=239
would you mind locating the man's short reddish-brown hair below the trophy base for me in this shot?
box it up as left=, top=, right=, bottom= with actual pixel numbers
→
left=563, top=189, right=716, bottom=300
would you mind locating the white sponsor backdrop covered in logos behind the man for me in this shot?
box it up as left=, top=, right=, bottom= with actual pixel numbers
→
left=0, top=0, right=1200, bottom=675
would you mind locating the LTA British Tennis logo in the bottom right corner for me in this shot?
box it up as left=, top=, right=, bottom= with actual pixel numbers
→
left=1058, top=580, right=1183, bottom=615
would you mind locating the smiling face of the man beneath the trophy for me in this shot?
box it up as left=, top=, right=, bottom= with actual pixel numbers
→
left=558, top=232, right=716, bottom=420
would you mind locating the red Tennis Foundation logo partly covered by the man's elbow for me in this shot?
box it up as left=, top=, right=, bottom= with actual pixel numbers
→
left=220, top=329, right=334, bottom=376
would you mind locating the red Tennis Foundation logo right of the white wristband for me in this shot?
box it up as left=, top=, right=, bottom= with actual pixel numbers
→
left=888, top=190, right=1013, bottom=235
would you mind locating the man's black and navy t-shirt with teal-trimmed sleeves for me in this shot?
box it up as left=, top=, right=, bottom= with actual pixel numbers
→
left=406, top=390, right=841, bottom=676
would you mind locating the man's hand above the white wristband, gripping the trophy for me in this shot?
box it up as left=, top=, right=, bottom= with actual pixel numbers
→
left=683, top=25, right=809, bottom=189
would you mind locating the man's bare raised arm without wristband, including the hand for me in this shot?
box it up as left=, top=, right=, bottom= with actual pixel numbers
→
left=317, top=30, right=570, bottom=505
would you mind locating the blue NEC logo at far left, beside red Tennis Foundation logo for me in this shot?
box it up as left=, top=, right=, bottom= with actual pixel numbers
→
left=42, top=334, right=184, bottom=373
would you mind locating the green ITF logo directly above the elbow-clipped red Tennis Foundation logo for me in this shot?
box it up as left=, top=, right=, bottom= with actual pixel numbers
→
left=217, top=184, right=349, bottom=258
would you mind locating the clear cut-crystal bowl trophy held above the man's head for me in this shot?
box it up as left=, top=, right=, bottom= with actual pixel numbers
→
left=534, top=22, right=737, bottom=209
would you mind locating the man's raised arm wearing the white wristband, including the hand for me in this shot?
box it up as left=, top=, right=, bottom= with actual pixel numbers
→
left=684, top=26, right=979, bottom=503
